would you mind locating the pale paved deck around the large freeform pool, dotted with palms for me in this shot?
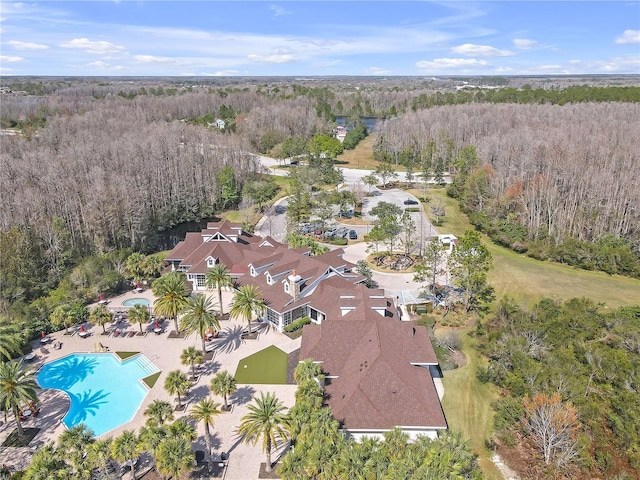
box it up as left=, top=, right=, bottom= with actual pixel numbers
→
left=0, top=290, right=300, bottom=480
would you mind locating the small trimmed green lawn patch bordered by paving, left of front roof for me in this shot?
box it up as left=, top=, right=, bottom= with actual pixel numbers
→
left=235, top=346, right=287, bottom=385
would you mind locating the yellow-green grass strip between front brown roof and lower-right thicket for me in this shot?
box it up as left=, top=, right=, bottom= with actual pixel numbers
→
left=442, top=329, right=502, bottom=479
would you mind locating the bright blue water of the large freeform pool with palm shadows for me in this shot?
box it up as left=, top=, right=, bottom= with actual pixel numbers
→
left=36, top=353, right=158, bottom=436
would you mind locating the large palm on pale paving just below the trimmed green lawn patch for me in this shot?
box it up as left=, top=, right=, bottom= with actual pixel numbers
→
left=238, top=392, right=289, bottom=472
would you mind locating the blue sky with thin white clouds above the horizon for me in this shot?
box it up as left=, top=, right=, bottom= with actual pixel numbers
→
left=0, top=0, right=640, bottom=76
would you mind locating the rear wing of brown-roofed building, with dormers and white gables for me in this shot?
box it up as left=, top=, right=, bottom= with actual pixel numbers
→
left=165, top=222, right=397, bottom=331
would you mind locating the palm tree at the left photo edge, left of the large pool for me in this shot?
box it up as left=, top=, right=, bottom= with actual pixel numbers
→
left=0, top=360, right=38, bottom=435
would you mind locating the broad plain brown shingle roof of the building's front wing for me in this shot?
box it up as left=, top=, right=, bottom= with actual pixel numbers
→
left=300, top=316, right=447, bottom=430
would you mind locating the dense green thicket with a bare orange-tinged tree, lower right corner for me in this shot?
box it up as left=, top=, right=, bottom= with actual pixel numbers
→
left=477, top=299, right=640, bottom=479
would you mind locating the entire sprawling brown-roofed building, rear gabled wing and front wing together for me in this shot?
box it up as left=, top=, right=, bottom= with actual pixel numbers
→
left=166, top=222, right=447, bottom=439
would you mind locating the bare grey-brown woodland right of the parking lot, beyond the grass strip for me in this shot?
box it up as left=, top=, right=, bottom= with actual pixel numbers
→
left=377, top=103, right=640, bottom=276
